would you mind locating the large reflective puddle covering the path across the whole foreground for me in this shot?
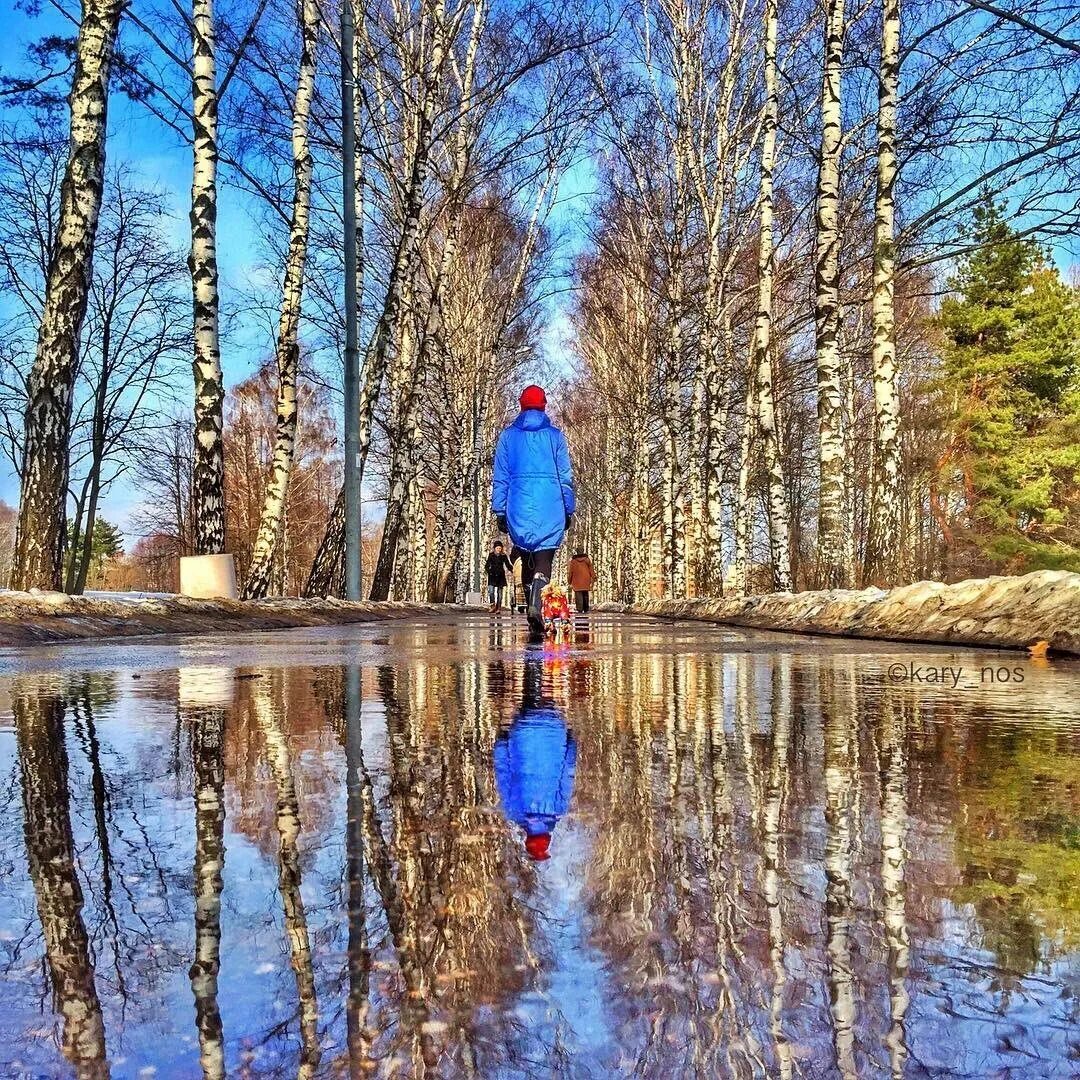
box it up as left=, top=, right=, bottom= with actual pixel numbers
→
left=0, top=616, right=1080, bottom=1078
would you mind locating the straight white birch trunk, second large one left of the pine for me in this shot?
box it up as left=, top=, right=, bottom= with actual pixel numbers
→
left=814, top=0, right=851, bottom=589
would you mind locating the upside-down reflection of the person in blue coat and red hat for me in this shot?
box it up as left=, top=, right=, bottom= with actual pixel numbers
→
left=495, top=661, right=578, bottom=861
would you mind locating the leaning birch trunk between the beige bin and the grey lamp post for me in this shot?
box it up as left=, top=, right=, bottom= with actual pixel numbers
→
left=244, top=0, right=319, bottom=599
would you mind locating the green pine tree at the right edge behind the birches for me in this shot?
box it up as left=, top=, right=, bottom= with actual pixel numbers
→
left=937, top=200, right=1080, bottom=572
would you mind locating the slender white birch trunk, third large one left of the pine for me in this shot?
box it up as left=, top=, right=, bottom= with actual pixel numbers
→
left=753, top=0, right=792, bottom=592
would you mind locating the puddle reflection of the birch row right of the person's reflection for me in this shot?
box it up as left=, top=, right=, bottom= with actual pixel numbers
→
left=571, top=643, right=920, bottom=1076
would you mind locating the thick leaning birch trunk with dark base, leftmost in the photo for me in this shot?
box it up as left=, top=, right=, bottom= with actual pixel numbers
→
left=11, top=0, right=123, bottom=590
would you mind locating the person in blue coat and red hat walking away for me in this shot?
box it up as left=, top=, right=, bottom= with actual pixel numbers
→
left=491, top=386, right=576, bottom=634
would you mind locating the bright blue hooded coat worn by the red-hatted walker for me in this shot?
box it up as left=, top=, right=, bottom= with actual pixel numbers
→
left=491, top=408, right=575, bottom=551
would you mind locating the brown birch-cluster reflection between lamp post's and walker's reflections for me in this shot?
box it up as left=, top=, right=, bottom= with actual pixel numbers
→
left=354, top=664, right=557, bottom=1076
